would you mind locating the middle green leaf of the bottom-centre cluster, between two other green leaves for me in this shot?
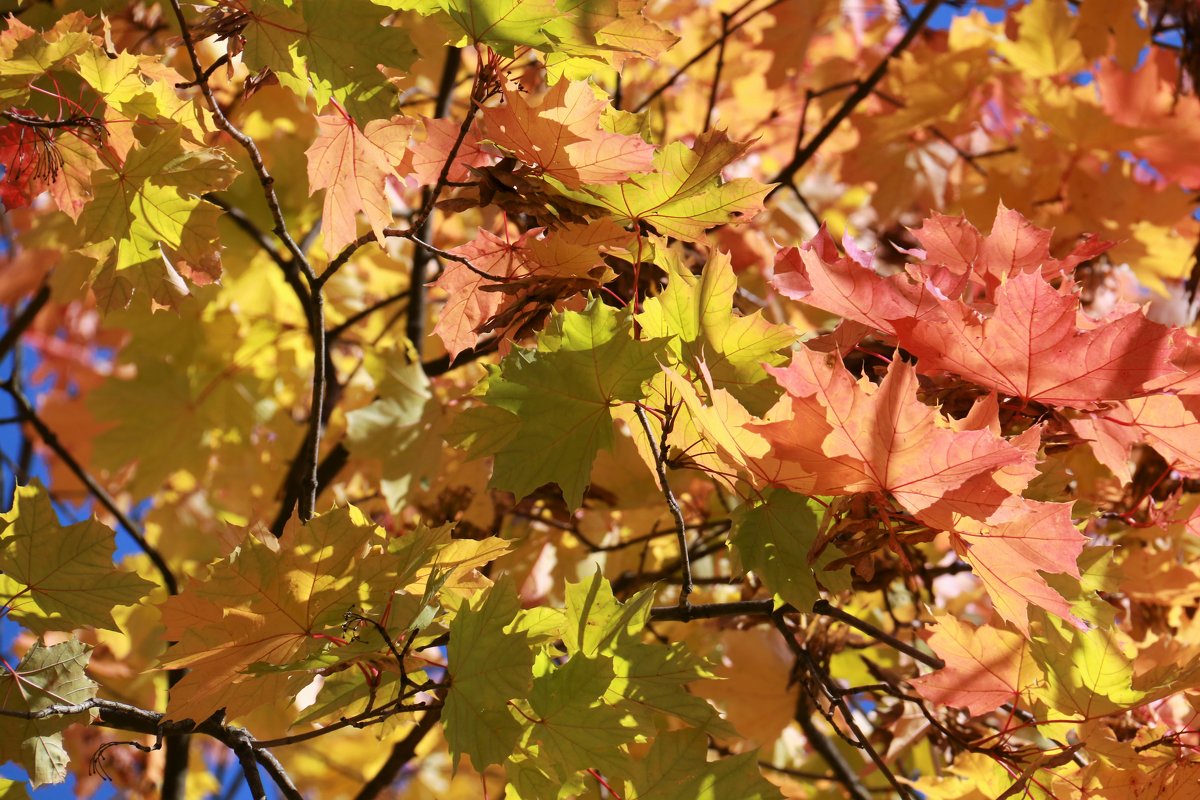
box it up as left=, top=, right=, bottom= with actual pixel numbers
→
left=522, top=655, right=637, bottom=778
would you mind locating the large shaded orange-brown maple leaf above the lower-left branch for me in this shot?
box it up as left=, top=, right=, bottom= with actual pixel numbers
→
left=154, top=506, right=446, bottom=721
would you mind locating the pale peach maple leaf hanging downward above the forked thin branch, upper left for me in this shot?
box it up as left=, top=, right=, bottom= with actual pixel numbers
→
left=305, top=113, right=412, bottom=254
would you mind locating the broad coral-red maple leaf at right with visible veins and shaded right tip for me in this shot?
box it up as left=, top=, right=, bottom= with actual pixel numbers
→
left=894, top=272, right=1177, bottom=408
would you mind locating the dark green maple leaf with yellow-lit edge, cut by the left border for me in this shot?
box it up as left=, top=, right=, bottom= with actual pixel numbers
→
left=0, top=482, right=155, bottom=633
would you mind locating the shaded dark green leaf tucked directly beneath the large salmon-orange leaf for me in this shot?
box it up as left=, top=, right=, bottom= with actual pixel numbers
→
left=731, top=489, right=850, bottom=609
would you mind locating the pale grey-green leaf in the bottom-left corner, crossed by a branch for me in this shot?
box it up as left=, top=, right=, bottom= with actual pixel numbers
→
left=0, top=639, right=96, bottom=788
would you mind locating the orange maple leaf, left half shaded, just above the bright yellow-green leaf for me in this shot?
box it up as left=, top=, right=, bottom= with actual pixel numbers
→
left=481, top=78, right=654, bottom=190
